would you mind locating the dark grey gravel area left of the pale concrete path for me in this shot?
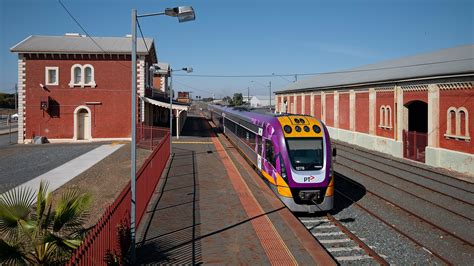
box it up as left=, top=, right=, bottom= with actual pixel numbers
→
left=0, top=143, right=102, bottom=193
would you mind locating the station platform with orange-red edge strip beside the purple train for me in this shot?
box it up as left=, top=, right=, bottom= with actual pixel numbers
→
left=133, top=112, right=336, bottom=265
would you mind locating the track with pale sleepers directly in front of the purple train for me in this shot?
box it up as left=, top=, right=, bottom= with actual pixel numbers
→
left=299, top=214, right=389, bottom=265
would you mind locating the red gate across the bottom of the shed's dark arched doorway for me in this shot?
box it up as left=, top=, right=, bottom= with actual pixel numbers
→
left=403, top=130, right=428, bottom=163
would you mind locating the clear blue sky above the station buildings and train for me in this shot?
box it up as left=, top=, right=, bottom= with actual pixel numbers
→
left=0, top=0, right=474, bottom=98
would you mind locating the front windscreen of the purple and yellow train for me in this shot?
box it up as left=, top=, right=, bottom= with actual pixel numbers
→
left=287, top=138, right=323, bottom=171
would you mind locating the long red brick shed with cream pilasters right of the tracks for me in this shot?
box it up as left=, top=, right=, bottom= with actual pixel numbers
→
left=276, top=45, right=474, bottom=174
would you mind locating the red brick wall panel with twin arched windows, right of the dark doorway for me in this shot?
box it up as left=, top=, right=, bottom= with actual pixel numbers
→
left=439, top=88, right=474, bottom=153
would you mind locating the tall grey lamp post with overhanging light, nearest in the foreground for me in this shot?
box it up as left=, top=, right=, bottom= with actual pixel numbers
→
left=130, top=6, right=196, bottom=264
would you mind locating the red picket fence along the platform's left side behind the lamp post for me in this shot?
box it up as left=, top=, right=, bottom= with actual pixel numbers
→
left=68, top=129, right=170, bottom=265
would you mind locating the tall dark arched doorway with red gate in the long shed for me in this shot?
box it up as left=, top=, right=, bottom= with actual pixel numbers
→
left=403, top=101, right=428, bottom=162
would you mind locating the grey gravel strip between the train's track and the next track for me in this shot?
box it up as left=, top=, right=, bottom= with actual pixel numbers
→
left=334, top=176, right=440, bottom=265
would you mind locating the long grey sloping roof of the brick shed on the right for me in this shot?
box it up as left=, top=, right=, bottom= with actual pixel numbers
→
left=276, top=45, right=474, bottom=94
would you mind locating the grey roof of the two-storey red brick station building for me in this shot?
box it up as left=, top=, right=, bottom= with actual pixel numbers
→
left=10, top=34, right=153, bottom=54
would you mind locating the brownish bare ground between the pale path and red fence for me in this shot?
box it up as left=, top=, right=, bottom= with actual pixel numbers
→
left=53, top=144, right=151, bottom=226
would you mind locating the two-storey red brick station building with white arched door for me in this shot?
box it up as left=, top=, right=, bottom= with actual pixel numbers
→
left=11, top=34, right=167, bottom=143
